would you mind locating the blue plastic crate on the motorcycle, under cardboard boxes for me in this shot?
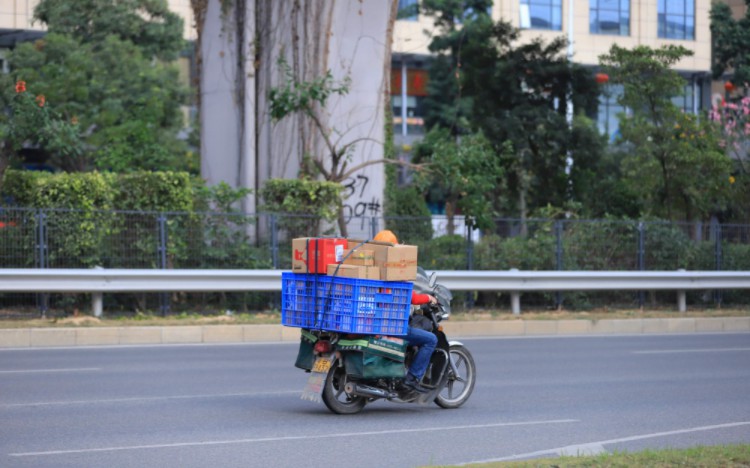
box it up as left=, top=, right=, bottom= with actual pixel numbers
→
left=281, top=272, right=413, bottom=336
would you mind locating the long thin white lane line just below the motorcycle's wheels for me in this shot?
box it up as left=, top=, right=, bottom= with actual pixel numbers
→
left=9, top=419, right=580, bottom=457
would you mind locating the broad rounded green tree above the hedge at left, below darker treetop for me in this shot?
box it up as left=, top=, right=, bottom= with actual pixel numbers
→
left=10, top=34, right=186, bottom=171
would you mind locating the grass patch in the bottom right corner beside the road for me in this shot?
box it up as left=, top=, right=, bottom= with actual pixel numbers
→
left=452, top=444, right=750, bottom=468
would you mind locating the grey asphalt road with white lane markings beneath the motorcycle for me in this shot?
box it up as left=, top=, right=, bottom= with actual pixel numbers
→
left=0, top=333, right=750, bottom=468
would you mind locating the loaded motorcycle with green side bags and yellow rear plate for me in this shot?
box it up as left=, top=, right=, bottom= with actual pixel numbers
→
left=295, top=268, right=476, bottom=414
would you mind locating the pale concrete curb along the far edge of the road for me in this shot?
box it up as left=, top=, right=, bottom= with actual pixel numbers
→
left=0, top=317, right=750, bottom=348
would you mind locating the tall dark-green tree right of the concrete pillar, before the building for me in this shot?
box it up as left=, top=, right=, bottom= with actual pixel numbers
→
left=424, top=0, right=599, bottom=217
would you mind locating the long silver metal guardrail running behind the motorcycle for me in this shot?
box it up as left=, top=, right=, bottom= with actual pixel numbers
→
left=0, top=268, right=750, bottom=316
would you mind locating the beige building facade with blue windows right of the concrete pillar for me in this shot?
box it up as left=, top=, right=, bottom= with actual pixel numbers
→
left=391, top=0, right=716, bottom=143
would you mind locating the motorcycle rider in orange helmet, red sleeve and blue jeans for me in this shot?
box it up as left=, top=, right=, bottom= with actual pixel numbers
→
left=373, top=229, right=437, bottom=393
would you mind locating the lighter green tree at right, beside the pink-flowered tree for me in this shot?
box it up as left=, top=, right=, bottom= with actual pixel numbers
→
left=600, top=45, right=731, bottom=221
